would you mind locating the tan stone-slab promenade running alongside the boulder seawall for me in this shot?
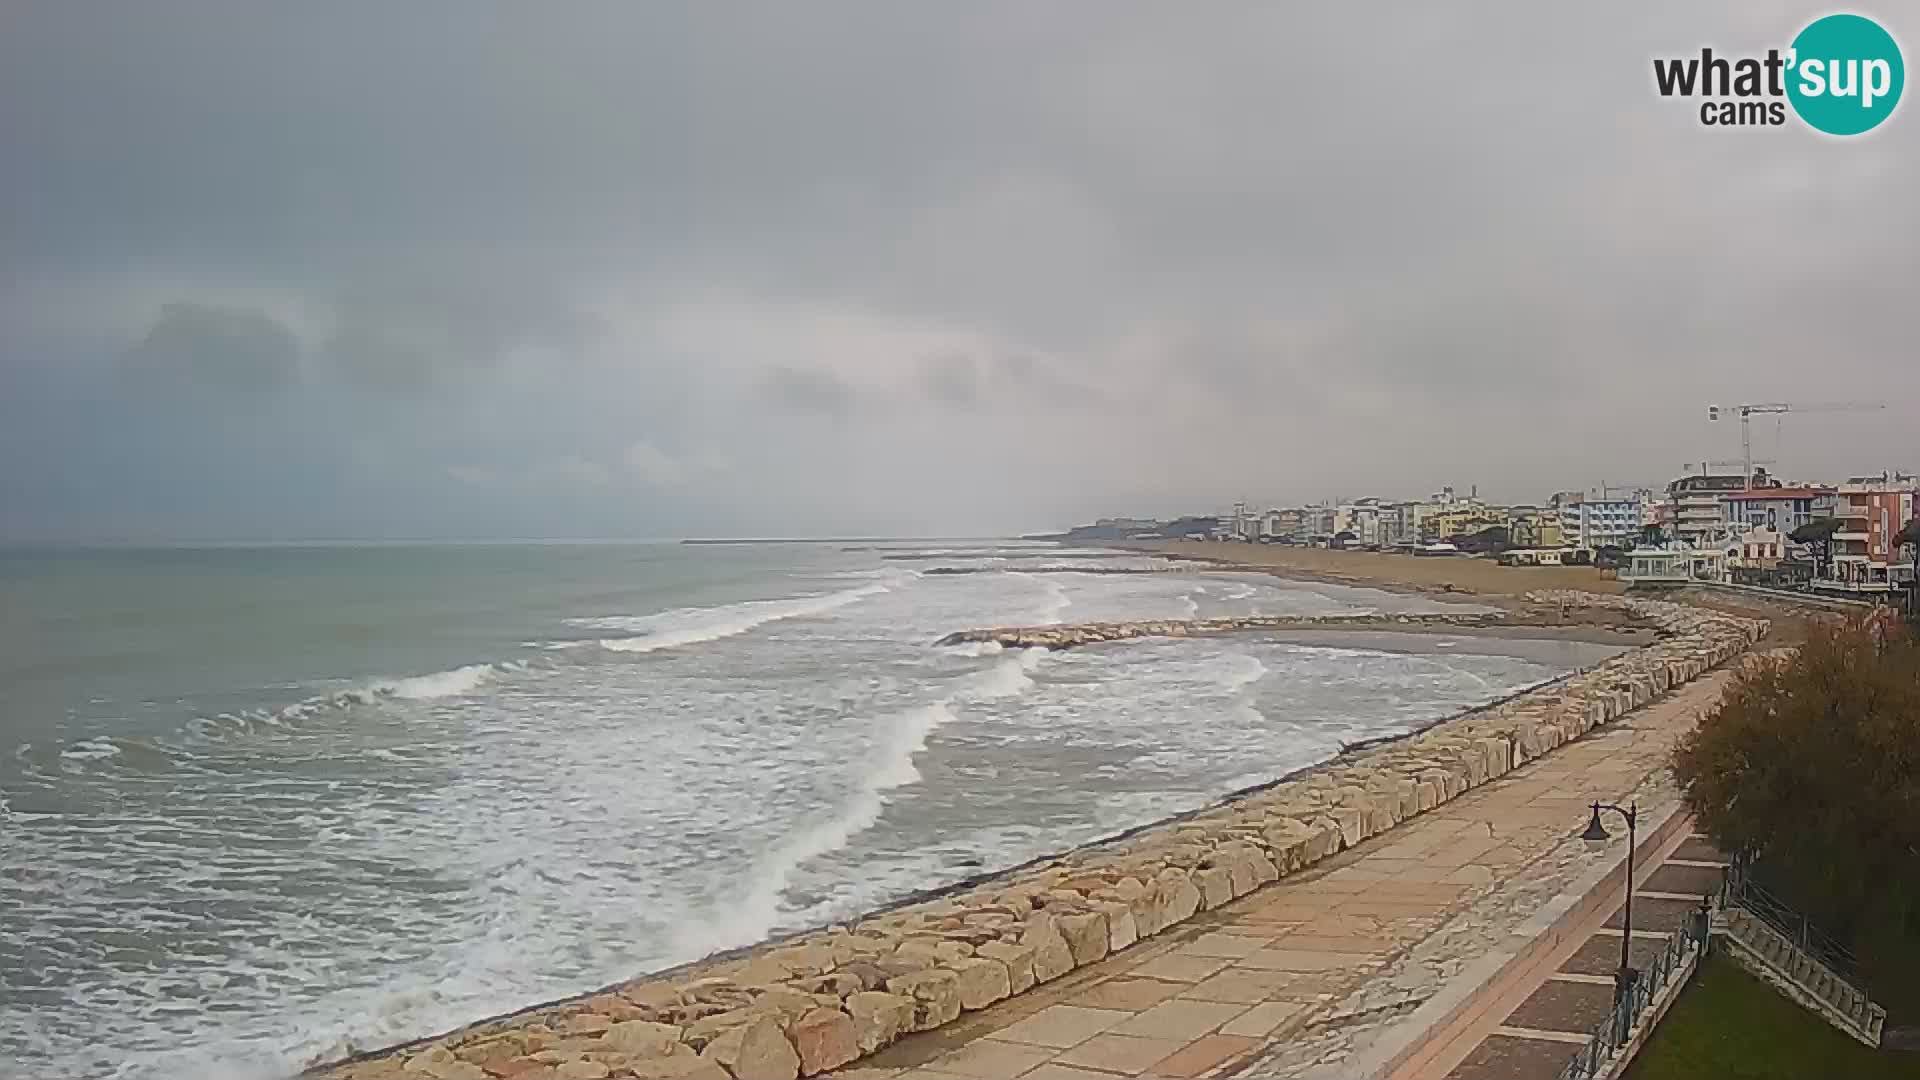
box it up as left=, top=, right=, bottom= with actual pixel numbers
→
left=833, top=671, right=1728, bottom=1080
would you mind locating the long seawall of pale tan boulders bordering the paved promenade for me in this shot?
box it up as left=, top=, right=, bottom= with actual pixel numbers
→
left=309, top=592, right=1766, bottom=1080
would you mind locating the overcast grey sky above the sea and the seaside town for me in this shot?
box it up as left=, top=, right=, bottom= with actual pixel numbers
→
left=0, top=0, right=1920, bottom=540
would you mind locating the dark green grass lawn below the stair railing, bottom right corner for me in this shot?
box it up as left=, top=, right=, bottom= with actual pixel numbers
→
left=1626, top=953, right=1920, bottom=1080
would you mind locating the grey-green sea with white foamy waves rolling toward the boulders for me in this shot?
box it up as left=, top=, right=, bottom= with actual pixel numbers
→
left=0, top=542, right=1609, bottom=1080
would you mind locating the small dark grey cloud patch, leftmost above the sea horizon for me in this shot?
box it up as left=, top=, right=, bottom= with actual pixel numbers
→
left=127, top=302, right=301, bottom=394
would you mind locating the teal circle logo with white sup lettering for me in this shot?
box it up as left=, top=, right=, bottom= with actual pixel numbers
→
left=1788, top=15, right=1907, bottom=135
